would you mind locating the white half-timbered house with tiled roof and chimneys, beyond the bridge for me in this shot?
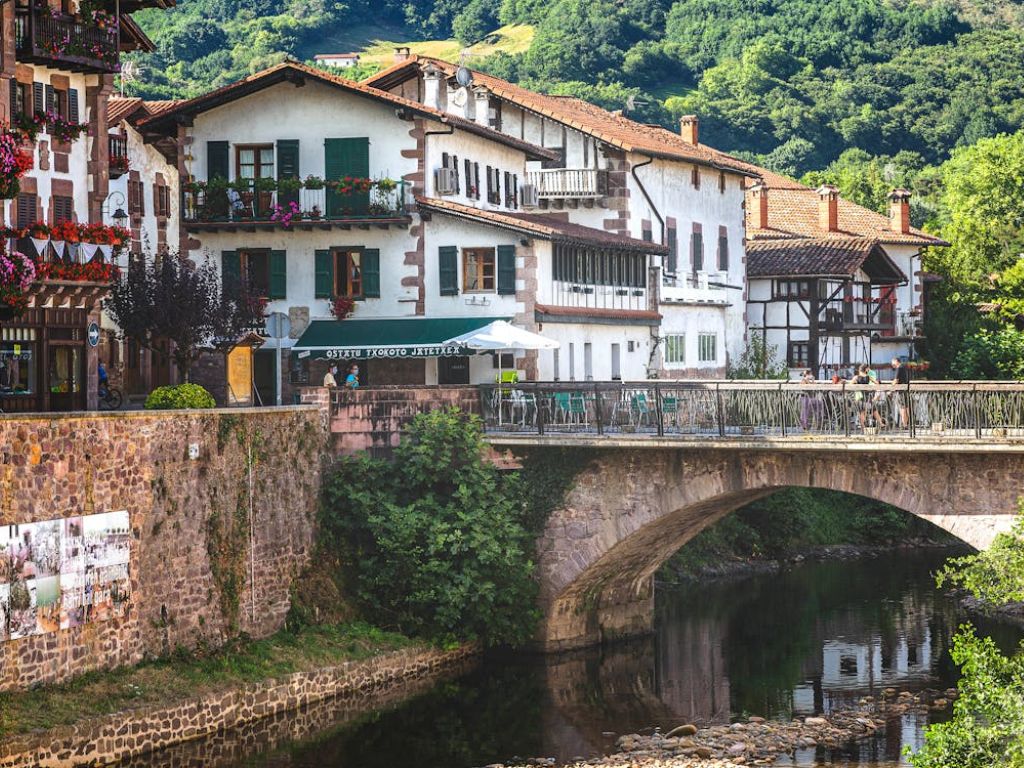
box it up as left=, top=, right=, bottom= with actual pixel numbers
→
left=746, top=169, right=946, bottom=378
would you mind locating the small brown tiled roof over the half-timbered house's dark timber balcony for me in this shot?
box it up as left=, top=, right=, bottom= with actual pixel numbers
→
left=746, top=238, right=906, bottom=283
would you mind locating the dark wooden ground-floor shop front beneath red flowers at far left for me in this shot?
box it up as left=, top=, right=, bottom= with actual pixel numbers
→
left=0, top=281, right=108, bottom=413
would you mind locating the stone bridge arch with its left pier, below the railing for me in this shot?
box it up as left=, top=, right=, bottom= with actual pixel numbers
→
left=539, top=449, right=1024, bottom=650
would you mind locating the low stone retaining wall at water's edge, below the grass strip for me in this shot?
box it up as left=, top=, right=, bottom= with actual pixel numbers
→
left=0, top=646, right=475, bottom=768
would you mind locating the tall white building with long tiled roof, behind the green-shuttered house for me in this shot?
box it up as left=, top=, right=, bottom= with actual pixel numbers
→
left=366, top=53, right=757, bottom=378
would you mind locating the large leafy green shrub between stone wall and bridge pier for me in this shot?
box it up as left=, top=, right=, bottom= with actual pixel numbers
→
left=322, top=409, right=537, bottom=646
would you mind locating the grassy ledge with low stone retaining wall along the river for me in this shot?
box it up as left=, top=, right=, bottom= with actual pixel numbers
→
left=0, top=623, right=477, bottom=768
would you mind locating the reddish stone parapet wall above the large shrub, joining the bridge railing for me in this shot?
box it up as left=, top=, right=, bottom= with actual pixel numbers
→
left=323, top=386, right=480, bottom=456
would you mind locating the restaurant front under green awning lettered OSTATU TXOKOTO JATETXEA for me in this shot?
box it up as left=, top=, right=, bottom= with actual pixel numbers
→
left=292, top=317, right=507, bottom=386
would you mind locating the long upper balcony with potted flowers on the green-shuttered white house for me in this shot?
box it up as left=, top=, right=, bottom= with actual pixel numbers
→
left=183, top=179, right=411, bottom=231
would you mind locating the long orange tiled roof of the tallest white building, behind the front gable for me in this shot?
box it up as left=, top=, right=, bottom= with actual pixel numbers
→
left=362, top=54, right=757, bottom=175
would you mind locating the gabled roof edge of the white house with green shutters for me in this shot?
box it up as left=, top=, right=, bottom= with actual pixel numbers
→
left=140, top=61, right=557, bottom=160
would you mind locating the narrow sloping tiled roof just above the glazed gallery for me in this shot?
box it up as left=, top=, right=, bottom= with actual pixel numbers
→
left=416, top=197, right=669, bottom=254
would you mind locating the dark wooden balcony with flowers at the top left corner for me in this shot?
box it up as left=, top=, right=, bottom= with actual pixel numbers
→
left=14, top=7, right=120, bottom=74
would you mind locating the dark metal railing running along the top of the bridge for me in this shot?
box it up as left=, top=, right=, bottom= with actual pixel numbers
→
left=480, top=381, right=1024, bottom=440
